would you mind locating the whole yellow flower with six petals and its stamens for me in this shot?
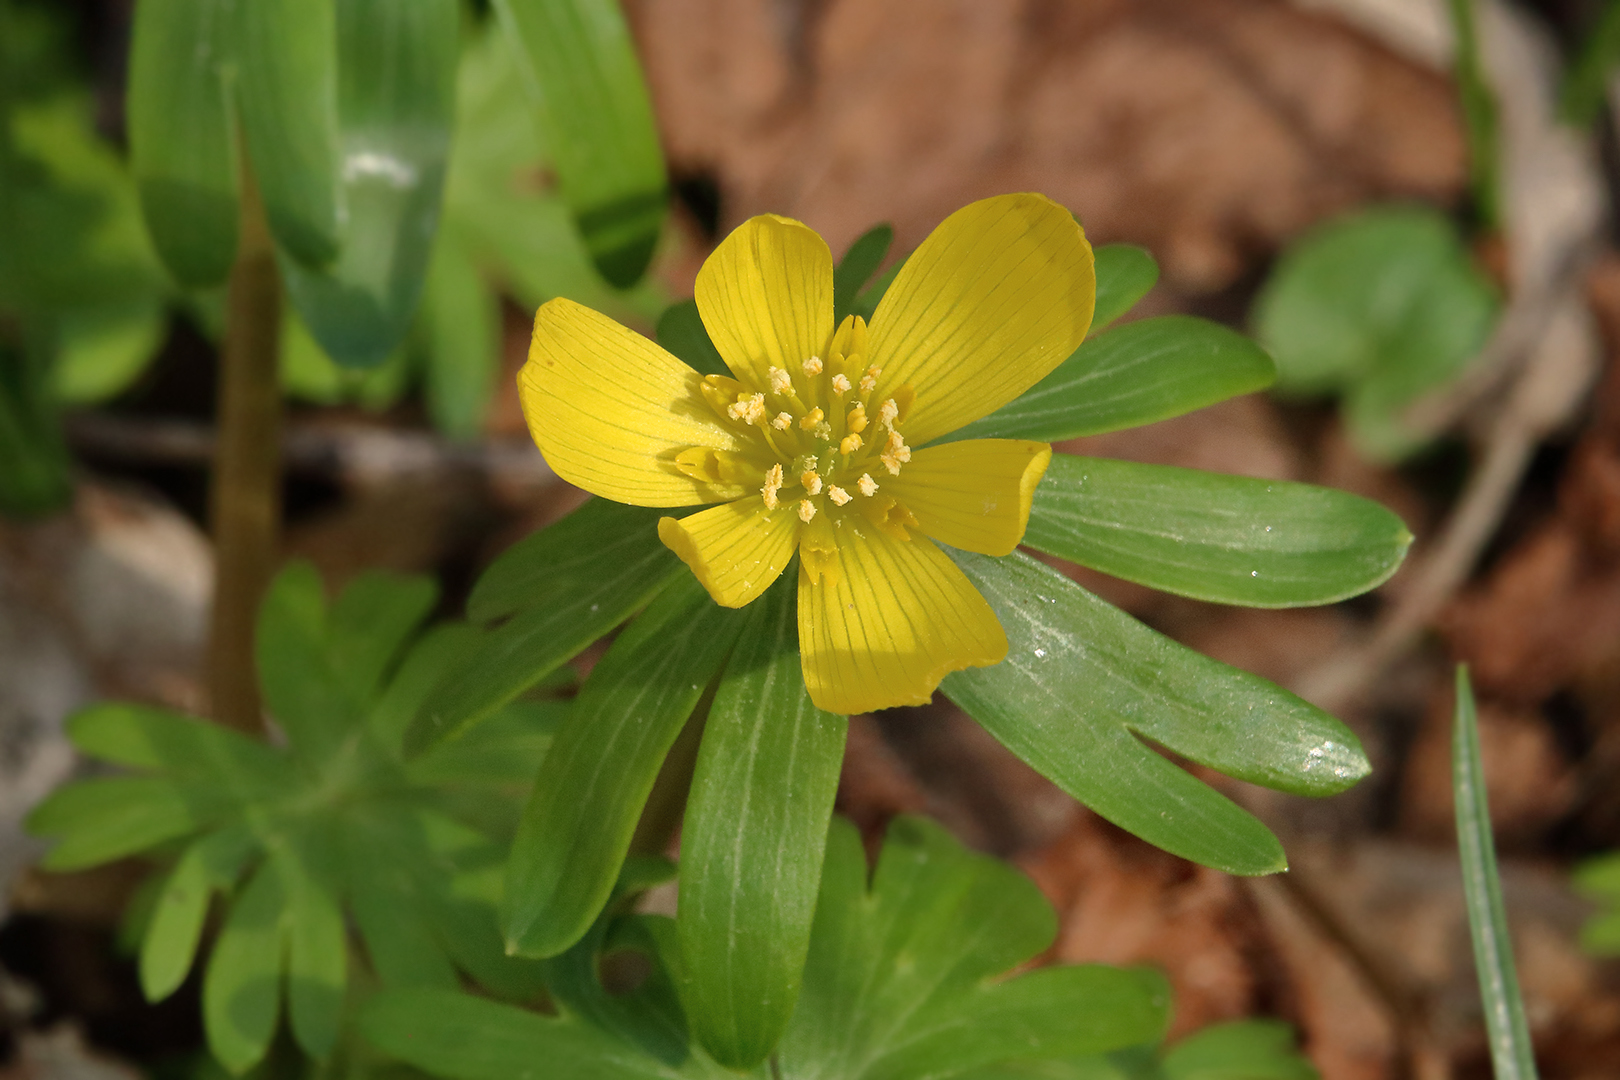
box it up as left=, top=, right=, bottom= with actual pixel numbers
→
left=518, top=194, right=1095, bottom=714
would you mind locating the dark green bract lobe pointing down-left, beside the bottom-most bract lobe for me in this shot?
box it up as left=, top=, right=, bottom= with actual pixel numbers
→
left=502, top=575, right=744, bottom=957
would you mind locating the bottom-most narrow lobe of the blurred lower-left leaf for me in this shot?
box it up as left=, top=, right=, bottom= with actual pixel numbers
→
left=203, top=861, right=287, bottom=1075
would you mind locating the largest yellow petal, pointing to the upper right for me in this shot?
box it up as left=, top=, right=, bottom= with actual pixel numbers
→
left=870, top=194, right=1097, bottom=445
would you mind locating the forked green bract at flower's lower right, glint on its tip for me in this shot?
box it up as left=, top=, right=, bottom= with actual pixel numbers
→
left=941, top=552, right=1369, bottom=874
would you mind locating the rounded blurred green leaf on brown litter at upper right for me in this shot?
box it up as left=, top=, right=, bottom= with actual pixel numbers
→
left=1254, top=206, right=1497, bottom=461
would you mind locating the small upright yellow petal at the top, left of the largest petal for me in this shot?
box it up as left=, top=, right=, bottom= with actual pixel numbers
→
left=695, top=214, right=833, bottom=390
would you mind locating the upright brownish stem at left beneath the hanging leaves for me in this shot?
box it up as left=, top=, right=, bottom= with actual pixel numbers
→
left=207, top=170, right=282, bottom=732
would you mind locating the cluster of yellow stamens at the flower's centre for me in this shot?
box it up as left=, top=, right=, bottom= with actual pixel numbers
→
left=676, top=316, right=915, bottom=569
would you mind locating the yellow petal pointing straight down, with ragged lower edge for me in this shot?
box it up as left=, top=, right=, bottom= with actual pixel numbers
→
left=799, top=518, right=1008, bottom=714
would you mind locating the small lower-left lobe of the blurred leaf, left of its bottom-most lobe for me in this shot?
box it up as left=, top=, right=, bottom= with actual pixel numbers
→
left=141, top=826, right=258, bottom=1001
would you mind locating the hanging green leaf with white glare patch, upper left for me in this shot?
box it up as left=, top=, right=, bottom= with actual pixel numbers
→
left=282, top=0, right=460, bottom=368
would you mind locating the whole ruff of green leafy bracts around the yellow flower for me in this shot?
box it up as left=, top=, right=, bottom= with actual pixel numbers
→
left=407, top=230, right=1411, bottom=1069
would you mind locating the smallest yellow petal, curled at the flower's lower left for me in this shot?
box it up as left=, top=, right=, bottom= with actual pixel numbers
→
left=658, top=495, right=799, bottom=607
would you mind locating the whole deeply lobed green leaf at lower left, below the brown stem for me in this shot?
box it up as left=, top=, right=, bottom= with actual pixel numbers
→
left=29, top=563, right=564, bottom=1072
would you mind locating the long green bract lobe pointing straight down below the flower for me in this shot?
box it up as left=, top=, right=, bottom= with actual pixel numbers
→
left=676, top=575, right=847, bottom=1069
